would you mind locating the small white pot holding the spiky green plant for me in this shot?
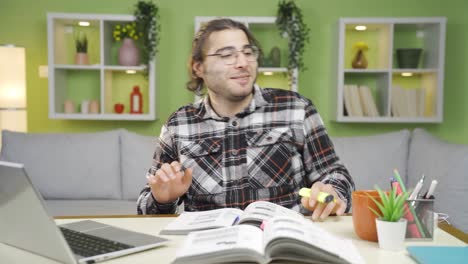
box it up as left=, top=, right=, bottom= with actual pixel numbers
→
left=375, top=218, right=407, bottom=251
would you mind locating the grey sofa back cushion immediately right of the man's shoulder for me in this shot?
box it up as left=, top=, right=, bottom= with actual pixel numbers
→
left=332, top=130, right=410, bottom=190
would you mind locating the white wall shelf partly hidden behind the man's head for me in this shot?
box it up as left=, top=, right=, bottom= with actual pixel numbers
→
left=195, top=16, right=298, bottom=91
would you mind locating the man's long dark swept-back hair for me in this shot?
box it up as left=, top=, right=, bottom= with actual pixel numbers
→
left=187, top=18, right=262, bottom=95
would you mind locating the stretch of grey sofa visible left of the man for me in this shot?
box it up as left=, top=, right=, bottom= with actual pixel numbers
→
left=0, top=129, right=157, bottom=216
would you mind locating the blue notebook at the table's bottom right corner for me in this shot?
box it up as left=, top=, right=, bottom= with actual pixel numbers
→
left=406, top=246, right=468, bottom=264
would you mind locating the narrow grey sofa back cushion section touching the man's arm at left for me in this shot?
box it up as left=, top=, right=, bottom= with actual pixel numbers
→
left=120, top=130, right=158, bottom=200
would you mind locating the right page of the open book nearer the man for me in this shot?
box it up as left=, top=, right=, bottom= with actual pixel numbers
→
left=239, top=201, right=304, bottom=225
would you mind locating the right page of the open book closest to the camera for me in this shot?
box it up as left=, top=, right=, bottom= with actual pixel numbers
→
left=264, top=217, right=363, bottom=263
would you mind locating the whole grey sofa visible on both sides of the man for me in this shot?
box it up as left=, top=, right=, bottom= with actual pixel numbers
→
left=0, top=129, right=468, bottom=232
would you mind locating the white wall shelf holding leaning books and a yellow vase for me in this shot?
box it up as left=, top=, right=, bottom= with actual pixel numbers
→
left=330, top=17, right=446, bottom=123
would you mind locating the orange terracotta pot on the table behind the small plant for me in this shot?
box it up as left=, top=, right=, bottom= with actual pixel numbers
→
left=352, top=190, right=381, bottom=242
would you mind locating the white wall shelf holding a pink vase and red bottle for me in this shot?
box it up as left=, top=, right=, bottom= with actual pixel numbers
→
left=47, top=13, right=156, bottom=120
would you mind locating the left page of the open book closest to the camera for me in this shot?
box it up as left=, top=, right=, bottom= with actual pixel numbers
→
left=174, top=225, right=264, bottom=264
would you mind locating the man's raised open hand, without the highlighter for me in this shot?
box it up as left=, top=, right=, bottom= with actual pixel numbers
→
left=146, top=161, right=193, bottom=203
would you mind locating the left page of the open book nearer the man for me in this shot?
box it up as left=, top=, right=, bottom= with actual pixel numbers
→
left=160, top=208, right=243, bottom=235
